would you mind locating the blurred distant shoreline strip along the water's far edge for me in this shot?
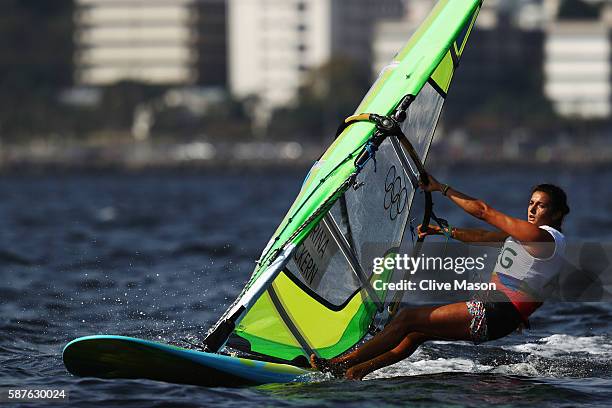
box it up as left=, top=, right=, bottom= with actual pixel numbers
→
left=0, top=141, right=612, bottom=173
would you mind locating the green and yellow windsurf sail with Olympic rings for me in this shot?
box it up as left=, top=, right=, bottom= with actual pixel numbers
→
left=204, top=0, right=482, bottom=365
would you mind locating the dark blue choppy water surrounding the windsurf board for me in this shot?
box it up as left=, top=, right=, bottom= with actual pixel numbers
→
left=0, top=169, right=612, bottom=407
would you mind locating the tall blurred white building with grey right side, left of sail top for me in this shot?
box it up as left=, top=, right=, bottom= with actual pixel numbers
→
left=228, top=0, right=403, bottom=122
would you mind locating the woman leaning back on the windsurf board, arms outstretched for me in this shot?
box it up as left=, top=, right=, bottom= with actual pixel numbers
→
left=311, top=176, right=569, bottom=380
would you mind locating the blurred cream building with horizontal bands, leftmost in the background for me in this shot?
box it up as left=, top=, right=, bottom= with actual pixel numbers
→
left=74, top=0, right=198, bottom=85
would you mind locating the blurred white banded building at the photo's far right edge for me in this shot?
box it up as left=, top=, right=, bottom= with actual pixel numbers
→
left=544, top=21, right=612, bottom=118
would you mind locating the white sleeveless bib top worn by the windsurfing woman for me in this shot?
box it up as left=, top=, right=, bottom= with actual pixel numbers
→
left=494, top=225, right=566, bottom=301
